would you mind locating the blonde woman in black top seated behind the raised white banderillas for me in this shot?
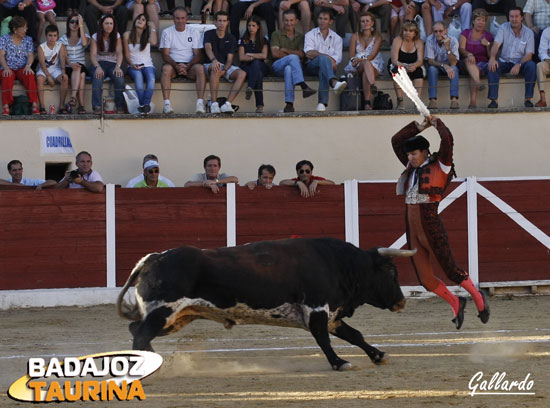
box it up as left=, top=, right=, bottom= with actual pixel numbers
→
left=390, top=22, right=424, bottom=109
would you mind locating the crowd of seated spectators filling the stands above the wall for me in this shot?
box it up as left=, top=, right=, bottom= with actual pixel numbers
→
left=0, top=0, right=550, bottom=115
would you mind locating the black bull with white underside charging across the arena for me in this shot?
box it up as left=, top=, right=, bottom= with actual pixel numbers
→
left=117, top=238, right=414, bottom=370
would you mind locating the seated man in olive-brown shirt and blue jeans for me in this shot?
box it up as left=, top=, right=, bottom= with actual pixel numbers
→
left=270, top=8, right=316, bottom=112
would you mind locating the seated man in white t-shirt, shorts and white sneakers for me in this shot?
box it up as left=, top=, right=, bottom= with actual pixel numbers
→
left=160, top=7, right=210, bottom=114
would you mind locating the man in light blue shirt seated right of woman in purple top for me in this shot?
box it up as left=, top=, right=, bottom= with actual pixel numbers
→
left=487, top=7, right=537, bottom=108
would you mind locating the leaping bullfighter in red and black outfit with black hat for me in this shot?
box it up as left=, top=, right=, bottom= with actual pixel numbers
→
left=391, top=115, right=490, bottom=330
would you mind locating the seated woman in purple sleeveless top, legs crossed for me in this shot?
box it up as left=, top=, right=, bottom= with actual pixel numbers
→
left=458, top=8, right=494, bottom=109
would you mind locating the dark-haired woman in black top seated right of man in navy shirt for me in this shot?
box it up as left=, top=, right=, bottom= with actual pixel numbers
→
left=239, top=15, right=269, bottom=113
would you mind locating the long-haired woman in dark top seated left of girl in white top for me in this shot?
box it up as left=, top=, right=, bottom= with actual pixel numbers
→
left=90, top=14, right=126, bottom=115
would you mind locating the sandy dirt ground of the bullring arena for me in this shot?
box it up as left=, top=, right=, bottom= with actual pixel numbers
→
left=0, top=296, right=550, bottom=408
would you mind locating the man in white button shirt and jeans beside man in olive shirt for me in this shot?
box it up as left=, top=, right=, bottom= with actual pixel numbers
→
left=304, top=10, right=347, bottom=112
